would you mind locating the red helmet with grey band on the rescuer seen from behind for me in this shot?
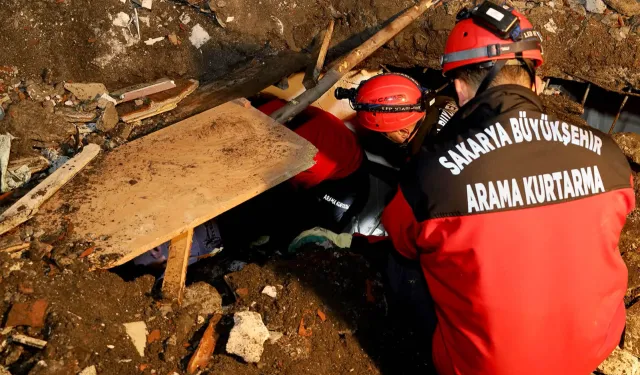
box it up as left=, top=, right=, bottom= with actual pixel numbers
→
left=441, top=1, right=543, bottom=74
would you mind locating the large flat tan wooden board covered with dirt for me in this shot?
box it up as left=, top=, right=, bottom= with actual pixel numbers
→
left=36, top=101, right=317, bottom=268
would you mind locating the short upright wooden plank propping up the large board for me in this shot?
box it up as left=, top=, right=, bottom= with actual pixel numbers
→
left=162, top=228, right=193, bottom=305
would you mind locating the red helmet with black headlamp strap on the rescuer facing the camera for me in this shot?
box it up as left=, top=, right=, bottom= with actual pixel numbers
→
left=352, top=73, right=425, bottom=133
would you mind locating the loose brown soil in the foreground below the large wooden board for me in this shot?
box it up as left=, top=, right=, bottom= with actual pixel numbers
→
left=0, top=239, right=426, bottom=375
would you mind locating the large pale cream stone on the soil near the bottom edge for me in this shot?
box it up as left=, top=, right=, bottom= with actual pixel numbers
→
left=226, top=311, right=269, bottom=363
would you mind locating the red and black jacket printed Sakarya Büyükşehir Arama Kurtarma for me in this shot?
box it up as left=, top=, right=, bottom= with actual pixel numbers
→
left=383, top=85, right=635, bottom=375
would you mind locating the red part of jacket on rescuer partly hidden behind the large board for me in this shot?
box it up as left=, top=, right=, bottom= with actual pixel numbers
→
left=258, top=99, right=364, bottom=189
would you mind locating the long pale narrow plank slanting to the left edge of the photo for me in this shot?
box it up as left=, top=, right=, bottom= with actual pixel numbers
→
left=0, top=144, right=100, bottom=235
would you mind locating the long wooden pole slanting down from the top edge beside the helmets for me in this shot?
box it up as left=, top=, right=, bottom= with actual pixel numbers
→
left=271, top=0, right=442, bottom=124
